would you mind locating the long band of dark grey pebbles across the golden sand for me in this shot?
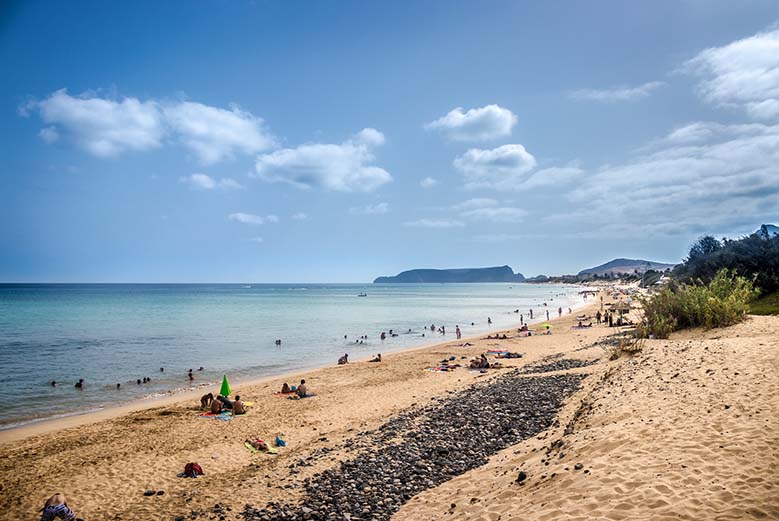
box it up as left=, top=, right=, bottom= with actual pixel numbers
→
left=242, top=370, right=585, bottom=521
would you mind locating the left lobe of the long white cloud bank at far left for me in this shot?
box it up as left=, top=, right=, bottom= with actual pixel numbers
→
left=29, top=89, right=165, bottom=157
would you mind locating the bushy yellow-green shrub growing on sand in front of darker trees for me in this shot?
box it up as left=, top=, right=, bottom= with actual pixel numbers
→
left=636, top=269, right=758, bottom=338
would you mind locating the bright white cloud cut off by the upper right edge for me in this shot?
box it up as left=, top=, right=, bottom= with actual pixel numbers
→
left=684, top=30, right=779, bottom=119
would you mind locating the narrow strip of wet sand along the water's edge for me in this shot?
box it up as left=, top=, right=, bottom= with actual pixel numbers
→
left=0, top=288, right=603, bottom=446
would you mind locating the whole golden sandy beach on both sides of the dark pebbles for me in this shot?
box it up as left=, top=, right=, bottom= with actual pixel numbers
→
left=0, top=290, right=779, bottom=520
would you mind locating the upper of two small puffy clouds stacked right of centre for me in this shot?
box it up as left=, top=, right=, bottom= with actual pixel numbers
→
left=425, top=105, right=517, bottom=141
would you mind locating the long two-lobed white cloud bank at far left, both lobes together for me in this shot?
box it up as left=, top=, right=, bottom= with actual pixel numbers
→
left=22, top=89, right=275, bottom=164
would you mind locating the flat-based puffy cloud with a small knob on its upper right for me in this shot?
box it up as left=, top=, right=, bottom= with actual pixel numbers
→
left=254, top=128, right=392, bottom=192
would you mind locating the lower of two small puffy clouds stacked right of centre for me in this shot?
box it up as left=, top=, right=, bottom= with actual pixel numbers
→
left=454, top=145, right=536, bottom=188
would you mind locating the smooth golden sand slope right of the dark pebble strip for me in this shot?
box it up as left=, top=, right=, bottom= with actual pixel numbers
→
left=395, top=317, right=779, bottom=520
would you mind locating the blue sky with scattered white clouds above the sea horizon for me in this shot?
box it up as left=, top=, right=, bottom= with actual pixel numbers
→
left=0, top=0, right=779, bottom=282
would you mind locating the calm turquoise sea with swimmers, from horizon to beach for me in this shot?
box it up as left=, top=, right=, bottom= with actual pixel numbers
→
left=0, top=284, right=582, bottom=428
